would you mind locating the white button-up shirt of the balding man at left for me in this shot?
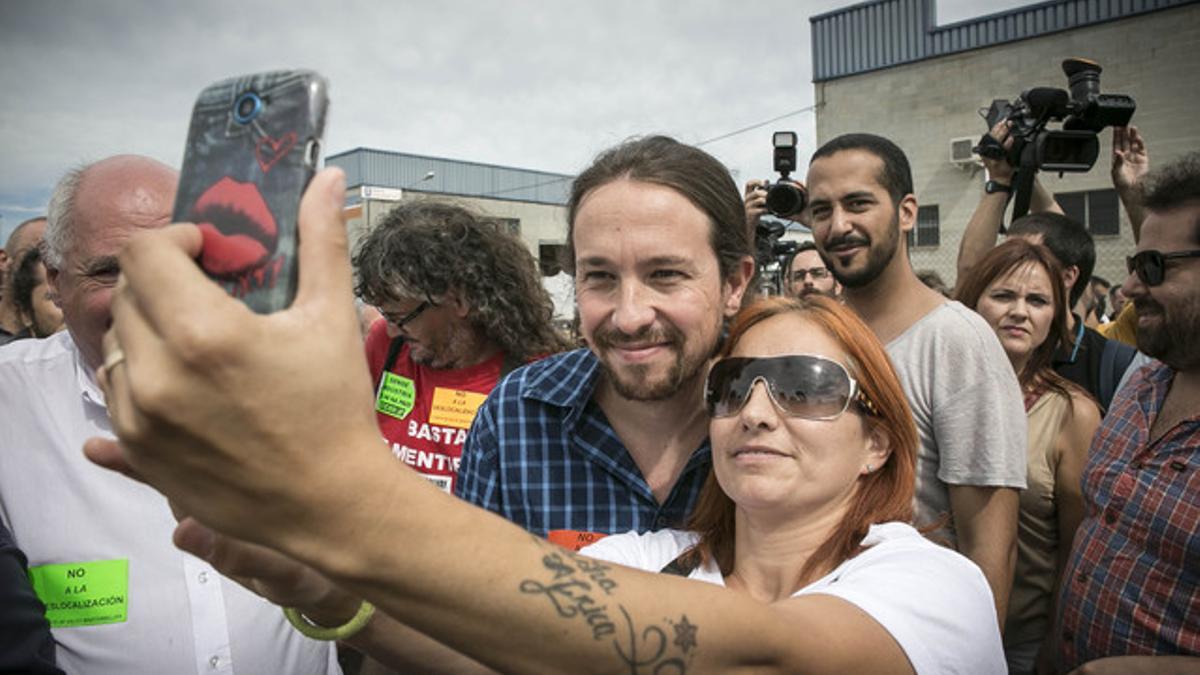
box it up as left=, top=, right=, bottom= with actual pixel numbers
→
left=0, top=330, right=341, bottom=675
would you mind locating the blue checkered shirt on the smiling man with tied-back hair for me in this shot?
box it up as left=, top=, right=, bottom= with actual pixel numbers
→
left=455, top=350, right=712, bottom=537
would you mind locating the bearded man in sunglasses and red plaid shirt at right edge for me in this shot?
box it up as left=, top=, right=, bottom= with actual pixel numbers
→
left=1057, top=153, right=1200, bottom=674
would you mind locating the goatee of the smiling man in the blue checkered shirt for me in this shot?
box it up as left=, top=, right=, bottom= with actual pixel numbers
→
left=592, top=319, right=720, bottom=401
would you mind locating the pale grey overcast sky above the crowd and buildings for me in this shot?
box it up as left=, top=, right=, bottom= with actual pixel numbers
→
left=0, top=0, right=1026, bottom=245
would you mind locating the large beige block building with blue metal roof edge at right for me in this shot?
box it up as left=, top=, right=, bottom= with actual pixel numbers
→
left=810, top=0, right=1200, bottom=282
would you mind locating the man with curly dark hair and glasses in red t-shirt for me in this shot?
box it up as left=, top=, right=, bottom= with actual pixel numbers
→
left=354, top=202, right=566, bottom=492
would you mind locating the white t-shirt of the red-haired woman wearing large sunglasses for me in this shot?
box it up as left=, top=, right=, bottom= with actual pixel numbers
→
left=580, top=522, right=1008, bottom=675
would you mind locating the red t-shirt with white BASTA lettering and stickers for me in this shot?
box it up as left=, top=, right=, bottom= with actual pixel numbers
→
left=366, top=319, right=504, bottom=494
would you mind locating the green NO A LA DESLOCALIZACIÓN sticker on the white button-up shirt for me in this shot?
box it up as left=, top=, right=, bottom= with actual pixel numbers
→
left=29, top=560, right=130, bottom=628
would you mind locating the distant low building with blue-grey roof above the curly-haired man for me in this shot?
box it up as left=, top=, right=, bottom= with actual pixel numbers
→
left=325, top=148, right=575, bottom=265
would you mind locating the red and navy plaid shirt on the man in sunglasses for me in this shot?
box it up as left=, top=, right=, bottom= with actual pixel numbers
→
left=1058, top=362, right=1200, bottom=670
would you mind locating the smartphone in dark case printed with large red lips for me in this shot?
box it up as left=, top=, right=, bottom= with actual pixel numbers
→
left=174, top=70, right=329, bottom=313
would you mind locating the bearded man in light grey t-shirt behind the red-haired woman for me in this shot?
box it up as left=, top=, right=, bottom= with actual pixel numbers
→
left=805, top=133, right=1026, bottom=617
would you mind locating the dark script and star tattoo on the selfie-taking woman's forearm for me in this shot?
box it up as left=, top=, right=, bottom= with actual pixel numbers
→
left=520, top=548, right=698, bottom=674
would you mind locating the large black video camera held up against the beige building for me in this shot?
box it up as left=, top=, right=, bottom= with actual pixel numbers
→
left=974, top=59, right=1138, bottom=219
